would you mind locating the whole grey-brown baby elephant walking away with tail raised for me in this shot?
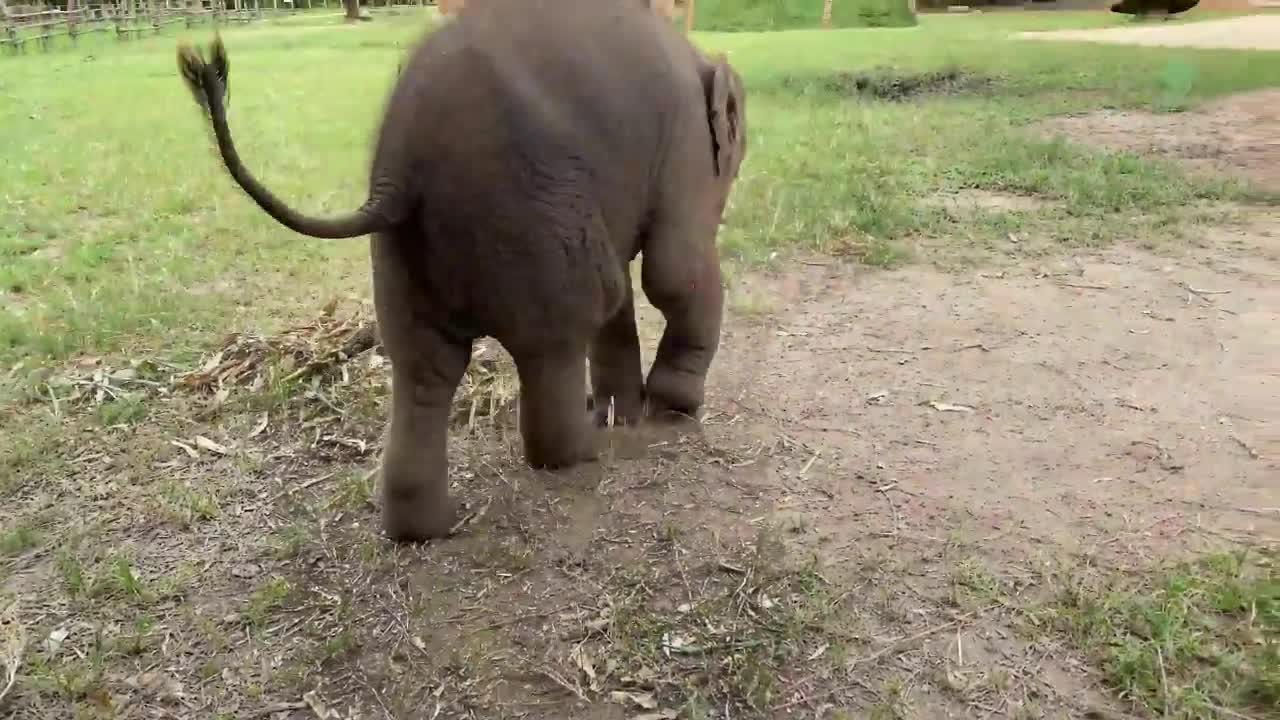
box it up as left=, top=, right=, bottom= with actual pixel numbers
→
left=179, top=0, right=746, bottom=541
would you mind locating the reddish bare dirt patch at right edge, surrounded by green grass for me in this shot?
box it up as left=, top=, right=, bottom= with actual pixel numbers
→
left=1041, top=87, right=1280, bottom=192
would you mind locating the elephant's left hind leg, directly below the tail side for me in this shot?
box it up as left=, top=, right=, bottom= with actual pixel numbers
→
left=381, top=332, right=471, bottom=542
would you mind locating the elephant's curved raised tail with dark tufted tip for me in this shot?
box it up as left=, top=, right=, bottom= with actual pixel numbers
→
left=178, top=36, right=399, bottom=238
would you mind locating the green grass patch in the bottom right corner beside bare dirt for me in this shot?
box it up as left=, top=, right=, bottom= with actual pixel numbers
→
left=1060, top=551, right=1280, bottom=717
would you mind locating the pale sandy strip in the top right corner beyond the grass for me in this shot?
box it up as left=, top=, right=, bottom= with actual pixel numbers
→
left=1018, top=14, right=1280, bottom=50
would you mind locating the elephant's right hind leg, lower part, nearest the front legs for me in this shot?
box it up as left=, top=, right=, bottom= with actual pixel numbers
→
left=512, top=342, right=596, bottom=469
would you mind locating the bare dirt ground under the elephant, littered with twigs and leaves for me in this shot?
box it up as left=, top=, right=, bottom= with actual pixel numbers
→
left=0, top=98, right=1280, bottom=720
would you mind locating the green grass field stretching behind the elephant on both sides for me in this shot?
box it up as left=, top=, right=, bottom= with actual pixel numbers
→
left=0, top=6, right=1280, bottom=361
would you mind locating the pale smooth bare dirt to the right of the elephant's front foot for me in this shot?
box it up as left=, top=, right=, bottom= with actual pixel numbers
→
left=716, top=213, right=1280, bottom=557
